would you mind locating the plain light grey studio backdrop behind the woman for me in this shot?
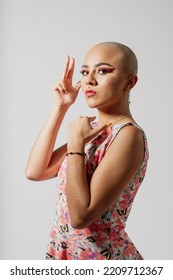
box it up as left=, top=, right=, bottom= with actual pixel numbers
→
left=0, top=0, right=173, bottom=259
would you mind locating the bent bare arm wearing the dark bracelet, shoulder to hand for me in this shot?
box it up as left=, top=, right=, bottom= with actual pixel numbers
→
left=67, top=119, right=144, bottom=228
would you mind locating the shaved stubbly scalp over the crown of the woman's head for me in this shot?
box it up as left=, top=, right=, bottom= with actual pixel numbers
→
left=92, top=42, right=138, bottom=75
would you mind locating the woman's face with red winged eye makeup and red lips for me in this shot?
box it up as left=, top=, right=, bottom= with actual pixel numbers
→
left=81, top=45, right=128, bottom=109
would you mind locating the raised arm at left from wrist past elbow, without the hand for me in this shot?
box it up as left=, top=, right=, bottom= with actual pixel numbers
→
left=26, top=104, right=67, bottom=181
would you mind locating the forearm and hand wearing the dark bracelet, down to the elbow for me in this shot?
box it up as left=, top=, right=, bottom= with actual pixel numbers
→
left=66, top=117, right=105, bottom=228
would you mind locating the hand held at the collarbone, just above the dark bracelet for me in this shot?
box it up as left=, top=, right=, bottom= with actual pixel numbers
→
left=68, top=117, right=107, bottom=149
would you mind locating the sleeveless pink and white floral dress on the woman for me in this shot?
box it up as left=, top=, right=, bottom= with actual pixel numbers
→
left=46, top=122, right=148, bottom=260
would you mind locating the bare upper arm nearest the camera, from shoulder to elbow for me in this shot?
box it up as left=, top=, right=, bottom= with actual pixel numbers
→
left=90, top=125, right=144, bottom=221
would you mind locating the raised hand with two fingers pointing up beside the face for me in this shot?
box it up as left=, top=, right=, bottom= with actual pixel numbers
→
left=52, top=56, right=81, bottom=107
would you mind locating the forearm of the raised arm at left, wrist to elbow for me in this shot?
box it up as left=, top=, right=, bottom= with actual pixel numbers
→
left=26, top=105, right=68, bottom=179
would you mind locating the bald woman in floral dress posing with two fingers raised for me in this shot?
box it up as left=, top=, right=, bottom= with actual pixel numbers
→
left=26, top=42, right=148, bottom=260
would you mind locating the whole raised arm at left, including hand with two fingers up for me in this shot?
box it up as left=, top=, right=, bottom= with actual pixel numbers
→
left=26, top=56, right=80, bottom=180
